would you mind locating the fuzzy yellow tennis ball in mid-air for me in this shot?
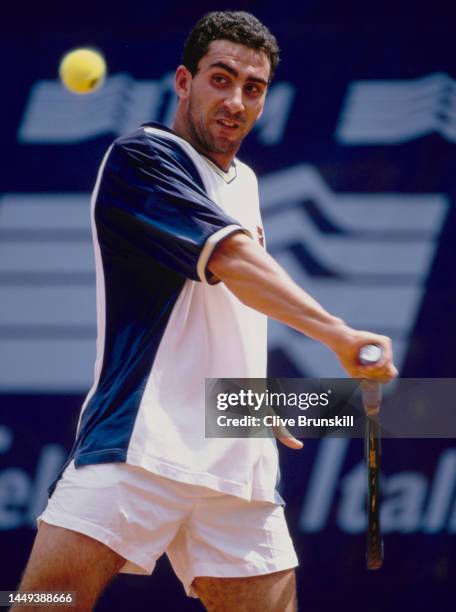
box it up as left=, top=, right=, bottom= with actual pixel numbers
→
left=59, top=49, right=106, bottom=94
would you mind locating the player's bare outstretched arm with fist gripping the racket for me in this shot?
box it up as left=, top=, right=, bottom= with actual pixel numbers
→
left=208, top=232, right=397, bottom=381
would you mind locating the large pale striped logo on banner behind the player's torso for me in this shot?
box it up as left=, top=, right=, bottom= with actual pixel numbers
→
left=0, top=165, right=449, bottom=392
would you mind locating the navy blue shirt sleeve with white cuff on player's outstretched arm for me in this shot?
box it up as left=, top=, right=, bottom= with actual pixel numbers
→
left=95, top=130, right=246, bottom=282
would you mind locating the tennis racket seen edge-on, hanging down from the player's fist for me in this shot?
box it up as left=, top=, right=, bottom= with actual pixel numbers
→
left=359, top=344, right=383, bottom=570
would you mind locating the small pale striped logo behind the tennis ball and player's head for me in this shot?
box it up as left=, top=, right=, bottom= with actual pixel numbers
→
left=17, top=73, right=296, bottom=145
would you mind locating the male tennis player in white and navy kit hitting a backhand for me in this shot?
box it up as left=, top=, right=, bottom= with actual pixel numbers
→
left=13, top=12, right=396, bottom=612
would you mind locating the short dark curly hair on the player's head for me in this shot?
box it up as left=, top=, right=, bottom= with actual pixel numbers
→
left=182, top=11, right=280, bottom=81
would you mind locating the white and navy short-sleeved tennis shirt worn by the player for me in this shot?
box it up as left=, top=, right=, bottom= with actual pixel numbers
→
left=54, top=123, right=280, bottom=503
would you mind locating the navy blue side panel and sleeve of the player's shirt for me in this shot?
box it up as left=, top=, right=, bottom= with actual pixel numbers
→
left=50, top=126, right=239, bottom=492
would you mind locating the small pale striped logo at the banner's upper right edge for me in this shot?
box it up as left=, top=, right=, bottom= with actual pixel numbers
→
left=335, top=73, right=456, bottom=145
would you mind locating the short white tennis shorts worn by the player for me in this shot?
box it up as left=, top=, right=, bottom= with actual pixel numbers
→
left=37, top=462, right=298, bottom=597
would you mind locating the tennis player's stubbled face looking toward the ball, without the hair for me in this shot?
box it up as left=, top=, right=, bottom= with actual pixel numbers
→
left=178, top=40, right=271, bottom=166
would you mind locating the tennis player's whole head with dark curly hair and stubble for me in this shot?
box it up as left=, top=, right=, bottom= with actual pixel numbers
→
left=174, top=12, right=279, bottom=167
